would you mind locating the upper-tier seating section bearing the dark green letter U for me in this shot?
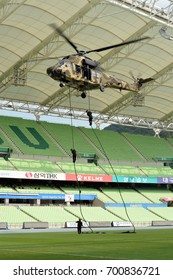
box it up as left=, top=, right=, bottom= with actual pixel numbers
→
left=1, top=117, right=65, bottom=157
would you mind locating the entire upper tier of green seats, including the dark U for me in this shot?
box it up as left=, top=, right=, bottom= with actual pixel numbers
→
left=0, top=117, right=173, bottom=166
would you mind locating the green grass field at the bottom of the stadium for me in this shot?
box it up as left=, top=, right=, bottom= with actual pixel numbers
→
left=0, top=229, right=173, bottom=260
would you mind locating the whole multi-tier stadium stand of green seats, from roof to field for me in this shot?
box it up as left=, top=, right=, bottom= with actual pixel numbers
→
left=0, top=117, right=173, bottom=230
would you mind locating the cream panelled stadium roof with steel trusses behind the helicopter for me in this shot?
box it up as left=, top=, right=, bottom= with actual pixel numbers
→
left=0, top=0, right=173, bottom=130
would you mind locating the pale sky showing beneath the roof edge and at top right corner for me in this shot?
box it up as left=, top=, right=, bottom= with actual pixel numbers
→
left=0, top=0, right=173, bottom=129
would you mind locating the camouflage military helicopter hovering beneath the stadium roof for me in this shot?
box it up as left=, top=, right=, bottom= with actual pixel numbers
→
left=47, top=24, right=152, bottom=98
